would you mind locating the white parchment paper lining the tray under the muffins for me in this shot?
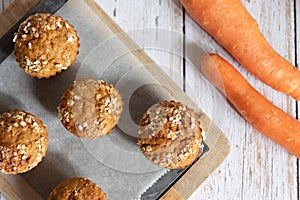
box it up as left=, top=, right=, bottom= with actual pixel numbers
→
left=0, top=0, right=176, bottom=200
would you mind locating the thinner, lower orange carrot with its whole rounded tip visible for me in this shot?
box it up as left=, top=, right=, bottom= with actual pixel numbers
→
left=201, top=54, right=300, bottom=158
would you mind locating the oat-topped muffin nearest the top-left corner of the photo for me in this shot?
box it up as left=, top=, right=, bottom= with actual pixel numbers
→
left=13, top=13, right=79, bottom=78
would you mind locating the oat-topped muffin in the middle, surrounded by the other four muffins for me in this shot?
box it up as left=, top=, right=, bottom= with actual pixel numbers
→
left=58, top=79, right=123, bottom=138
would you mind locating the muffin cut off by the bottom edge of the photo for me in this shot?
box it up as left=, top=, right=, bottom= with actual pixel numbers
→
left=48, top=178, right=106, bottom=200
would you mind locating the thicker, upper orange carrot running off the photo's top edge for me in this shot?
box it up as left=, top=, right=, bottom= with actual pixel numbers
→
left=181, top=0, right=300, bottom=100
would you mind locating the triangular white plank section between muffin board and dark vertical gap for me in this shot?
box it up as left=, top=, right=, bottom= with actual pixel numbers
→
left=96, top=0, right=183, bottom=86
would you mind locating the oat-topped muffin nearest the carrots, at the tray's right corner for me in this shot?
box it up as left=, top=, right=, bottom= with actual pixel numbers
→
left=138, top=101, right=203, bottom=169
